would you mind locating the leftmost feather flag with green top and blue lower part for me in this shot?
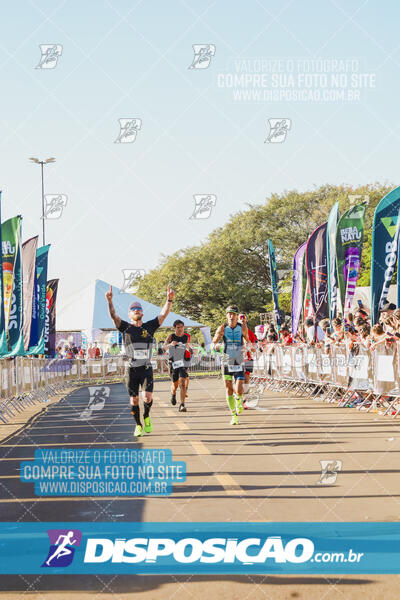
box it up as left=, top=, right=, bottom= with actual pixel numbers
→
left=1, top=216, right=25, bottom=357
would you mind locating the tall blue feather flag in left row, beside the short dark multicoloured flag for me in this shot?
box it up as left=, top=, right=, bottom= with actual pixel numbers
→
left=28, top=245, right=50, bottom=354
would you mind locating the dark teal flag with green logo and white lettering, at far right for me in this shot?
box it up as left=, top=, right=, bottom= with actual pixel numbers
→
left=371, top=187, right=400, bottom=324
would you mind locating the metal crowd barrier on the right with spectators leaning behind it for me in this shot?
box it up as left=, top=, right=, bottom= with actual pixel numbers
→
left=247, top=342, right=400, bottom=418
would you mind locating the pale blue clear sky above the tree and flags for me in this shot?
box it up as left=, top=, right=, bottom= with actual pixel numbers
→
left=0, top=0, right=400, bottom=326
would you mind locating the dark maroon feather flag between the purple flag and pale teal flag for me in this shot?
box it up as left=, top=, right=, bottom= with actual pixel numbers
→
left=306, top=223, right=329, bottom=322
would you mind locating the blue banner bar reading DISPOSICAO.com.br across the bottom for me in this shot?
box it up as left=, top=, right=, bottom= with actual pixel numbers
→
left=0, top=522, right=400, bottom=575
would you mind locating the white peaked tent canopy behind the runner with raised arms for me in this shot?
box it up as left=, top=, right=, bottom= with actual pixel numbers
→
left=56, top=279, right=204, bottom=331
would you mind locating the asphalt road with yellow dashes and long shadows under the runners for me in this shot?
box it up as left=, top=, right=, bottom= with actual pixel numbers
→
left=0, top=379, right=400, bottom=600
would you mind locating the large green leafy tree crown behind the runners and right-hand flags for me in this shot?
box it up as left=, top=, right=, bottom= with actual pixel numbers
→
left=138, top=183, right=393, bottom=328
